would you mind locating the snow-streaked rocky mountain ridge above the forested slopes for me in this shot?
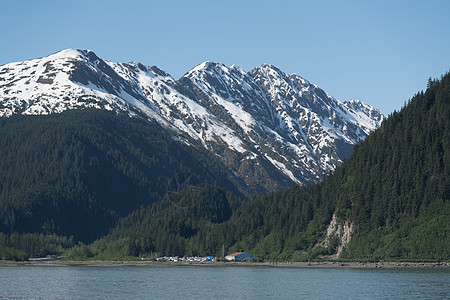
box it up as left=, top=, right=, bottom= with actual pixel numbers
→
left=0, top=49, right=384, bottom=191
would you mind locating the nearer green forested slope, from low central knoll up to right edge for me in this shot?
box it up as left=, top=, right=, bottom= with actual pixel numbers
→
left=85, top=75, right=450, bottom=260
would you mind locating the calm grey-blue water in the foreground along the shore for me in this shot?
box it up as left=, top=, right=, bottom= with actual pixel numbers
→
left=0, top=266, right=450, bottom=299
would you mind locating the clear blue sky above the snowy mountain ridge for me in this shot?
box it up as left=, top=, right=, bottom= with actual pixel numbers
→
left=0, top=0, right=450, bottom=114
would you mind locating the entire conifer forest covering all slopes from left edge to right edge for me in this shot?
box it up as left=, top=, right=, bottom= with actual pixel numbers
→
left=0, top=74, right=450, bottom=261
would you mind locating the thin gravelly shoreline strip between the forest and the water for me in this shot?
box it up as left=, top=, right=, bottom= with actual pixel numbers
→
left=0, top=260, right=450, bottom=269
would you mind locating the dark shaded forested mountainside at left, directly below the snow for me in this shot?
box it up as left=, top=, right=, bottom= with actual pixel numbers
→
left=0, top=110, right=247, bottom=242
